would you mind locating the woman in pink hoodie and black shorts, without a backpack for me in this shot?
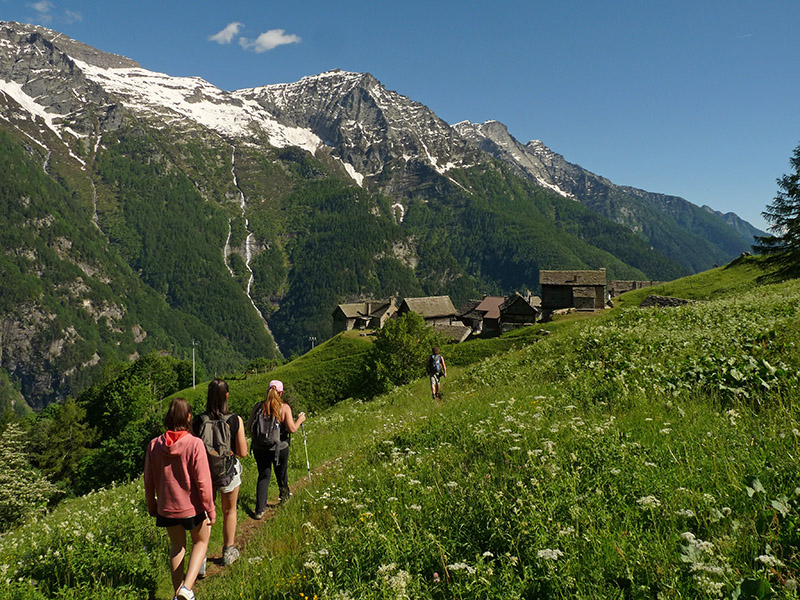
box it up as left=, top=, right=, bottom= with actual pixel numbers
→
left=144, top=398, right=217, bottom=600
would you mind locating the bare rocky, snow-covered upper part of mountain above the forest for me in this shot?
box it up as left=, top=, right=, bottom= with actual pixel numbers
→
left=0, top=23, right=479, bottom=191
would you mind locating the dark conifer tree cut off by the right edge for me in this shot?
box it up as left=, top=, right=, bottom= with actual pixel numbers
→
left=753, top=145, right=800, bottom=277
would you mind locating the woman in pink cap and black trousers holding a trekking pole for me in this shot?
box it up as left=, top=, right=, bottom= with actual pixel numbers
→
left=247, top=379, right=306, bottom=519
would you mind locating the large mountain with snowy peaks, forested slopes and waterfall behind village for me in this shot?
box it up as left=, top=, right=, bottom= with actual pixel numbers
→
left=0, top=23, right=764, bottom=406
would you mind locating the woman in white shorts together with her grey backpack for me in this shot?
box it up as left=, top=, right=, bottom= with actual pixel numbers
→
left=192, top=379, right=247, bottom=577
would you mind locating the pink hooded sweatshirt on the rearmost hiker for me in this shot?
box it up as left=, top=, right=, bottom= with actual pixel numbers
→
left=144, top=431, right=217, bottom=522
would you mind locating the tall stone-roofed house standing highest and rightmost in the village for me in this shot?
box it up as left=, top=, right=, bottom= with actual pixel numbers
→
left=539, top=269, right=606, bottom=311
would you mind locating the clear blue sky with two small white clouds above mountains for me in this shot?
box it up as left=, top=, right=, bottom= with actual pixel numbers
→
left=0, top=0, right=800, bottom=228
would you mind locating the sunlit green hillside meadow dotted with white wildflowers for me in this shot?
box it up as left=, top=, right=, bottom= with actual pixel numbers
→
left=0, top=260, right=800, bottom=600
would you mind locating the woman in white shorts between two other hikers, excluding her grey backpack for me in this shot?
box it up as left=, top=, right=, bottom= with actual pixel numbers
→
left=192, top=379, right=247, bottom=575
